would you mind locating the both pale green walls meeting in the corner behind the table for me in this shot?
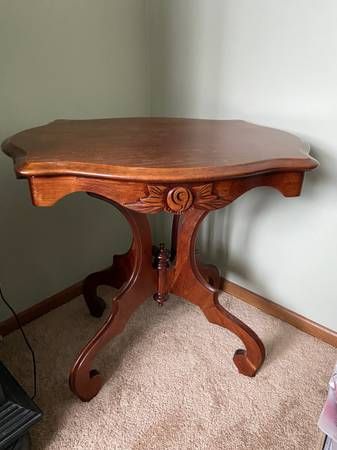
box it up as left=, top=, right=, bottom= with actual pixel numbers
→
left=0, top=0, right=337, bottom=329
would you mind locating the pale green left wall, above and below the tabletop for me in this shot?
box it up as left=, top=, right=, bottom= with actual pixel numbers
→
left=0, top=0, right=149, bottom=320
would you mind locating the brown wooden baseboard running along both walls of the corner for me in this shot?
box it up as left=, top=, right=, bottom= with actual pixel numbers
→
left=0, top=279, right=337, bottom=347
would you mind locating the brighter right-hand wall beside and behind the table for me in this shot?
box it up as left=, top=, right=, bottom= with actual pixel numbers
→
left=149, top=0, right=337, bottom=330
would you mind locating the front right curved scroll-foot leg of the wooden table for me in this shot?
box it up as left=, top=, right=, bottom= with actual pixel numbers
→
left=170, top=209, right=265, bottom=377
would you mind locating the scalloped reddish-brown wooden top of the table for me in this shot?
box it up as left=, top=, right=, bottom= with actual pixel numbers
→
left=2, top=118, right=318, bottom=182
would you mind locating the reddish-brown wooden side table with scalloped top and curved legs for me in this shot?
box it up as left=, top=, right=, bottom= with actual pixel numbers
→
left=2, top=118, right=318, bottom=401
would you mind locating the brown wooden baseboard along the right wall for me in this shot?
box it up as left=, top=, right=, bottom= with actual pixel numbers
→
left=222, top=279, right=337, bottom=347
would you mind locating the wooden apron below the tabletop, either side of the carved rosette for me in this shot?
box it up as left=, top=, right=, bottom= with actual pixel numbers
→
left=29, top=172, right=303, bottom=213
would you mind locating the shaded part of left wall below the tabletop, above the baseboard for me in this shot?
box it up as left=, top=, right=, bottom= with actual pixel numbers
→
left=0, top=155, right=131, bottom=320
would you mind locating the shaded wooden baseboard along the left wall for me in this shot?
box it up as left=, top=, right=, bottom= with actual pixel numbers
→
left=0, top=281, right=83, bottom=336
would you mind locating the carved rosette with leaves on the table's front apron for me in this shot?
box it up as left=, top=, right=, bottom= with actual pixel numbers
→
left=124, top=183, right=228, bottom=214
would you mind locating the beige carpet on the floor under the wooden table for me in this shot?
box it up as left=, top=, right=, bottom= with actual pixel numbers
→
left=0, top=291, right=337, bottom=450
